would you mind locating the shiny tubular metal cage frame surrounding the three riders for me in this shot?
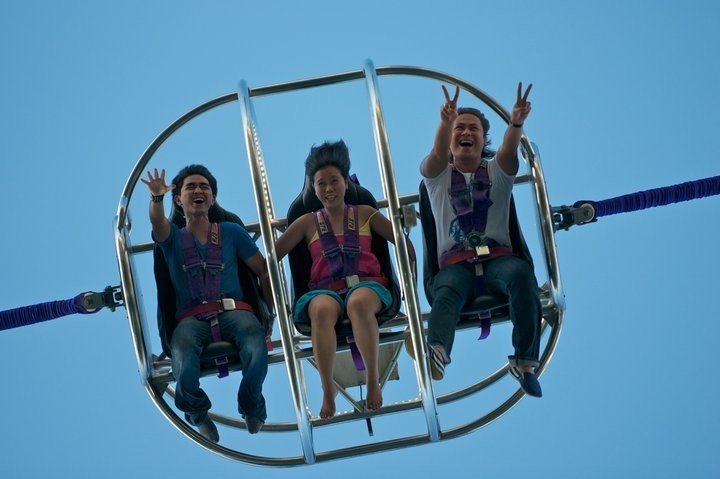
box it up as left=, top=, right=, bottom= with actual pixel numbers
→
left=114, top=60, right=565, bottom=467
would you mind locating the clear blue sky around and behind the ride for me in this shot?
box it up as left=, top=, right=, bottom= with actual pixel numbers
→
left=0, top=0, right=720, bottom=478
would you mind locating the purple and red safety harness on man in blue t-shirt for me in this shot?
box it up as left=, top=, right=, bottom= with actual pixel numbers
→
left=175, top=223, right=254, bottom=378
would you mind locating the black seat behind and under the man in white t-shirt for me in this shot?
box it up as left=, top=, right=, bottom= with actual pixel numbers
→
left=419, top=180, right=533, bottom=312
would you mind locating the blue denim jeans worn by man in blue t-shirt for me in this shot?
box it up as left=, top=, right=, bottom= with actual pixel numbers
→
left=170, top=311, right=267, bottom=426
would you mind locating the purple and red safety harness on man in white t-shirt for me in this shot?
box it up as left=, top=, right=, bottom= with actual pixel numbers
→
left=440, top=160, right=515, bottom=339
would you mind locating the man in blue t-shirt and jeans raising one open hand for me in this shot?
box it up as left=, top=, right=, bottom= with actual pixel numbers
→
left=141, top=165, right=272, bottom=442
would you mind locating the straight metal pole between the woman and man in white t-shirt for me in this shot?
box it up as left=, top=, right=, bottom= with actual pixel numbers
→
left=364, top=60, right=440, bottom=441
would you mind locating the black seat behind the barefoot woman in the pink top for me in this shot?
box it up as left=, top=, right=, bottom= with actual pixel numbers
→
left=287, top=175, right=401, bottom=334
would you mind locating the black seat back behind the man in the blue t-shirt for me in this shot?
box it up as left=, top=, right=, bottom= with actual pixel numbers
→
left=153, top=203, right=273, bottom=356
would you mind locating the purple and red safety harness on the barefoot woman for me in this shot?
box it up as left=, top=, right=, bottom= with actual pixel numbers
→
left=309, top=205, right=389, bottom=371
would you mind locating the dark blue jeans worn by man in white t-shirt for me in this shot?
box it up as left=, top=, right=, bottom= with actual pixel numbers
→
left=428, top=256, right=542, bottom=367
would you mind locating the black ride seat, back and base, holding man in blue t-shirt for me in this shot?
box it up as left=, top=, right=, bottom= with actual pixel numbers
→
left=153, top=203, right=272, bottom=371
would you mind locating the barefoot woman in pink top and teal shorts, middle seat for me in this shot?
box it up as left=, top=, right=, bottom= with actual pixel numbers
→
left=275, top=140, right=414, bottom=418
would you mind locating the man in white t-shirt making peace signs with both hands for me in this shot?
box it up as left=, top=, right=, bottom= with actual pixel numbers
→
left=420, top=84, right=542, bottom=397
